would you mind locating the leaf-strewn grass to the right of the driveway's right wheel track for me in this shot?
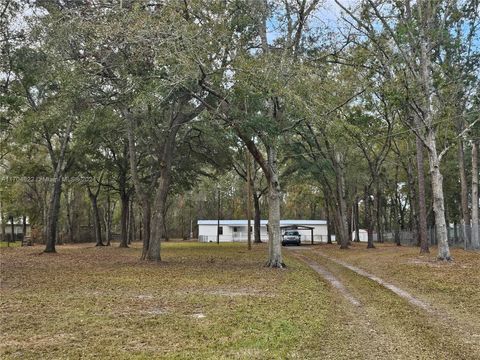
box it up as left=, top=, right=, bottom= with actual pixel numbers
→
left=308, top=243, right=480, bottom=334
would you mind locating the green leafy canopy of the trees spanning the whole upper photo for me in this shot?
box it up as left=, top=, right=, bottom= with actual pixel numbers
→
left=0, top=0, right=480, bottom=248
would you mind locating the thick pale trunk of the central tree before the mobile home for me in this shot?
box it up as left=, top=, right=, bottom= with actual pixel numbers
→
left=266, top=146, right=285, bottom=268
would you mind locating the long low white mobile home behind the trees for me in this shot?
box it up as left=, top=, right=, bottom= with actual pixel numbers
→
left=198, top=220, right=327, bottom=243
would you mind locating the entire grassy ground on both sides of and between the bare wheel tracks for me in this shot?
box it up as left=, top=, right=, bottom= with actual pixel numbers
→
left=0, top=242, right=480, bottom=360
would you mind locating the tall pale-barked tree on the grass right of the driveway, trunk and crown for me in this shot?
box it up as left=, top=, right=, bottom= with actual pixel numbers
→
left=337, top=0, right=480, bottom=260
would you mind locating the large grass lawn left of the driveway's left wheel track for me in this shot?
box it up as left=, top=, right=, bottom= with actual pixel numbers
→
left=0, top=243, right=332, bottom=359
